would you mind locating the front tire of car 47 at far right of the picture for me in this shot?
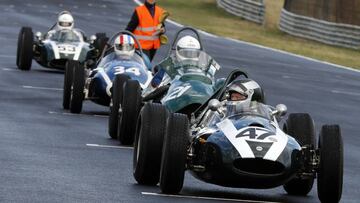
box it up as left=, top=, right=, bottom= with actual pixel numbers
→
left=317, top=125, right=344, bottom=203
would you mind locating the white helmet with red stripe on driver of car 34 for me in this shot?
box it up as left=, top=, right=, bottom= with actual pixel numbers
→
left=114, top=34, right=135, bottom=57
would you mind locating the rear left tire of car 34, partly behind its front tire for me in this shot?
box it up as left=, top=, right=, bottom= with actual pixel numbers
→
left=63, top=60, right=78, bottom=109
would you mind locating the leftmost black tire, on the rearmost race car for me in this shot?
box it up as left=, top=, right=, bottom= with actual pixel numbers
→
left=16, top=27, right=34, bottom=70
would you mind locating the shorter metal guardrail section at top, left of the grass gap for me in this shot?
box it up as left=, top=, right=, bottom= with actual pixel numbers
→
left=216, top=0, right=265, bottom=24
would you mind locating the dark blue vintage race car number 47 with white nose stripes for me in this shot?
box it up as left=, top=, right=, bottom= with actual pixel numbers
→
left=133, top=69, right=343, bottom=202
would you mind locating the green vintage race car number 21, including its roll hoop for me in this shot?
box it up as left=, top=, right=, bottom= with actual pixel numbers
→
left=117, top=27, right=224, bottom=145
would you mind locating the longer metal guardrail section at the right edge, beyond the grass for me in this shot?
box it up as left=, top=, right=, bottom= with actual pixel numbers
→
left=279, top=9, right=360, bottom=49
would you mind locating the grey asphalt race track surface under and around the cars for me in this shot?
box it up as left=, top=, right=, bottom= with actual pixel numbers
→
left=0, top=0, right=360, bottom=202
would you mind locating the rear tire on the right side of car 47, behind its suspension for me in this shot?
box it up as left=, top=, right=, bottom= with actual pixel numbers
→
left=284, top=113, right=316, bottom=196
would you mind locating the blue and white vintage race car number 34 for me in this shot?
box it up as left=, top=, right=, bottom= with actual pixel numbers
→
left=63, top=31, right=152, bottom=117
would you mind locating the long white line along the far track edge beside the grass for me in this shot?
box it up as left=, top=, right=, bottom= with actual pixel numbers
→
left=133, top=0, right=360, bottom=73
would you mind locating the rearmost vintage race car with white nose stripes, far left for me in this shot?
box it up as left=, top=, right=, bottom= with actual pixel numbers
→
left=16, top=24, right=107, bottom=70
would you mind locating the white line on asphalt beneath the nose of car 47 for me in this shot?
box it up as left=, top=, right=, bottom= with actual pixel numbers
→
left=141, top=192, right=279, bottom=203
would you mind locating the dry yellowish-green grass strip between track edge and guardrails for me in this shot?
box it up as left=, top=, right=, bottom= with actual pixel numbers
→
left=158, top=0, right=360, bottom=69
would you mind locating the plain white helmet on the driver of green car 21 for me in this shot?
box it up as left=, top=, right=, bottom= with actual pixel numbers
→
left=176, top=35, right=201, bottom=61
